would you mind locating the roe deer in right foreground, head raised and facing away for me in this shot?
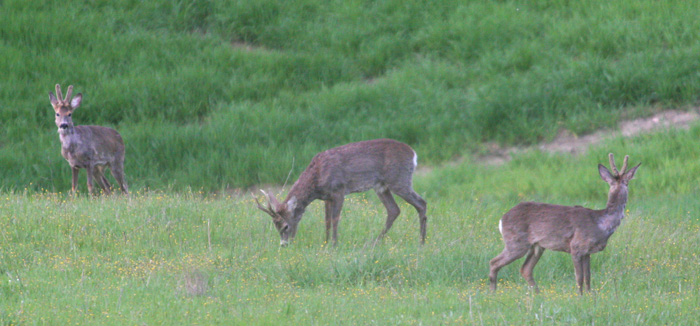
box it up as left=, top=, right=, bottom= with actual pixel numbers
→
left=489, top=153, right=641, bottom=294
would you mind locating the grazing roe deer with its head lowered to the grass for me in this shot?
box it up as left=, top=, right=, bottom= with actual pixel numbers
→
left=255, top=139, right=428, bottom=246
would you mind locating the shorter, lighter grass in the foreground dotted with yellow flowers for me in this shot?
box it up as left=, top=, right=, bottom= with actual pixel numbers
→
left=0, top=127, right=700, bottom=325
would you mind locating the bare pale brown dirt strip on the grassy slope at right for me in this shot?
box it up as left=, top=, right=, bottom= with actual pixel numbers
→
left=475, top=108, right=700, bottom=165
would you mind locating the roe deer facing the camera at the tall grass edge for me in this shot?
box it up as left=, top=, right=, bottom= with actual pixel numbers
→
left=49, top=84, right=129, bottom=194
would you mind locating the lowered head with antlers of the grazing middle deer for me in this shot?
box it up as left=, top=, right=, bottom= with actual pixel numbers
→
left=253, top=190, right=301, bottom=246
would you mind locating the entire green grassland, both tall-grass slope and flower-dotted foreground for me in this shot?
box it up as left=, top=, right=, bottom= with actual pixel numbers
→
left=0, top=0, right=700, bottom=325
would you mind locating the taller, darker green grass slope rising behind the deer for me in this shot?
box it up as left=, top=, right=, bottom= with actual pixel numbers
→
left=0, top=0, right=700, bottom=191
